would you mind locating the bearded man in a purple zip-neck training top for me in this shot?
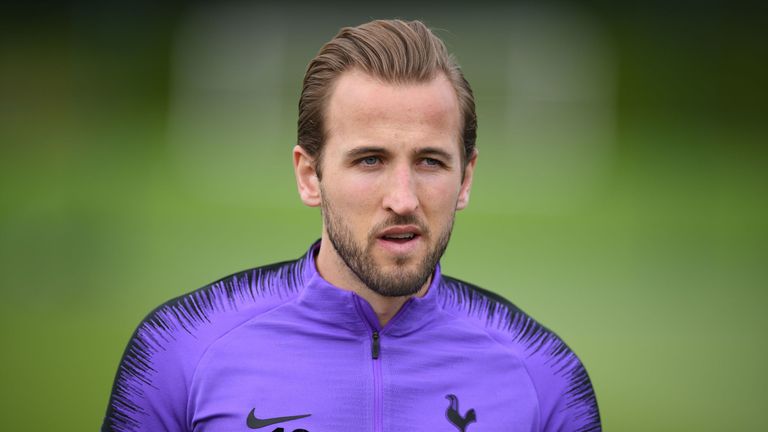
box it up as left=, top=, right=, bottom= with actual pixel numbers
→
left=103, top=21, right=600, bottom=432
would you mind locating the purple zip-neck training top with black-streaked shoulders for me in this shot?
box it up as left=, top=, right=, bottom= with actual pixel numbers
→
left=102, top=243, right=601, bottom=432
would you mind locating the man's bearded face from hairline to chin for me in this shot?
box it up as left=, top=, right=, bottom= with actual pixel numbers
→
left=300, top=70, right=475, bottom=296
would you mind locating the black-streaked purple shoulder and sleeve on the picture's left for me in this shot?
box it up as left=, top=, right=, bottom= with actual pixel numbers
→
left=103, top=259, right=306, bottom=431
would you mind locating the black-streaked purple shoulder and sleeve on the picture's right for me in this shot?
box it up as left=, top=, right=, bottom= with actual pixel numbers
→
left=440, top=276, right=600, bottom=431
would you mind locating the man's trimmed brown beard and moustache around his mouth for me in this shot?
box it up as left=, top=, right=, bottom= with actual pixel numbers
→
left=321, top=191, right=455, bottom=297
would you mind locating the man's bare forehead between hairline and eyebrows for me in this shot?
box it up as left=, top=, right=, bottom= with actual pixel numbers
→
left=325, top=70, right=461, bottom=152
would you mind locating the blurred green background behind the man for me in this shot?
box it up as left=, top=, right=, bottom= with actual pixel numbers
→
left=0, top=0, right=768, bottom=431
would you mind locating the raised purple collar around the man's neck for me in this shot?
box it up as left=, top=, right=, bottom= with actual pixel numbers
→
left=298, top=241, right=442, bottom=337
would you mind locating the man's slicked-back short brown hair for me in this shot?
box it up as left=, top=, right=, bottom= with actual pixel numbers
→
left=298, top=20, right=477, bottom=176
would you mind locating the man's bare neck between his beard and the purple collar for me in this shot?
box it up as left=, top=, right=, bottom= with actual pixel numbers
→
left=315, top=236, right=432, bottom=327
